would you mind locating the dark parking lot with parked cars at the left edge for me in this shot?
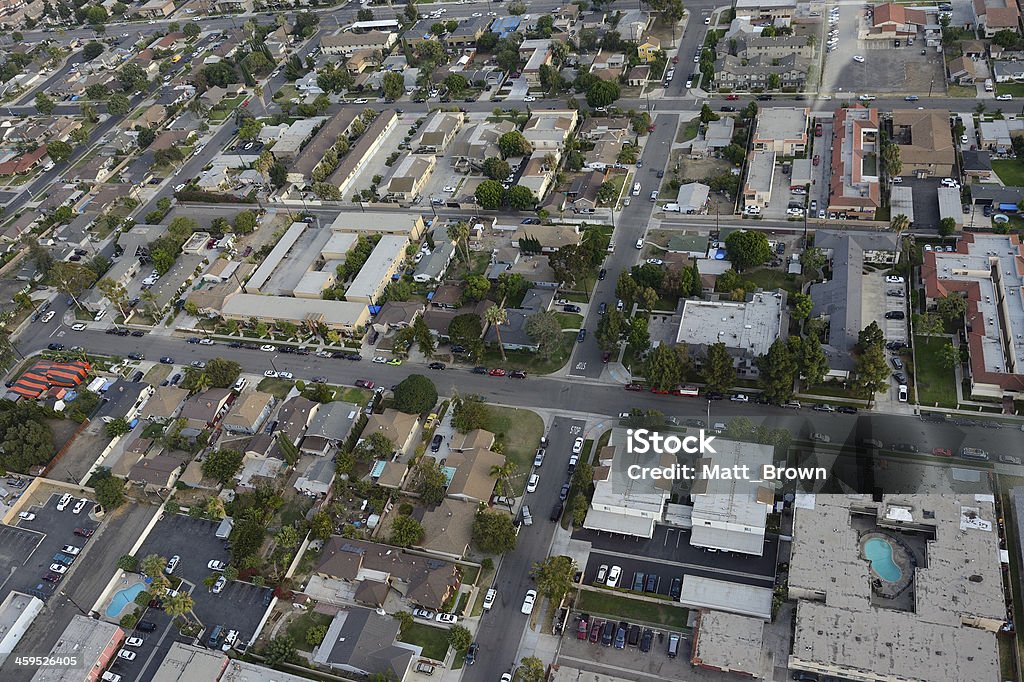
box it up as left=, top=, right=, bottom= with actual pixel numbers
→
left=0, top=493, right=96, bottom=599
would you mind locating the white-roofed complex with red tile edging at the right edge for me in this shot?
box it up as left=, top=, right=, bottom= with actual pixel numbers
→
left=921, top=232, right=1024, bottom=399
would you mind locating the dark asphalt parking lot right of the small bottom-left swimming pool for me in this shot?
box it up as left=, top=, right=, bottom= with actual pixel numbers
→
left=136, top=514, right=271, bottom=642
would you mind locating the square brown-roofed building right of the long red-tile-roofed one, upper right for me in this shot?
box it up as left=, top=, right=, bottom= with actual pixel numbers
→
left=892, top=109, right=956, bottom=177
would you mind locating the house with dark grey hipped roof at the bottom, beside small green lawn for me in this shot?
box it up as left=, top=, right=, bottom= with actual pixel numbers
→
left=311, top=607, right=421, bottom=682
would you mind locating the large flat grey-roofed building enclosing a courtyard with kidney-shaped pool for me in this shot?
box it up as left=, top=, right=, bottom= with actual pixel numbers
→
left=788, top=492, right=1007, bottom=682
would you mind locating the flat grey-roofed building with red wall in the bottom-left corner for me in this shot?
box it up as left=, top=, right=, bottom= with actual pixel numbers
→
left=32, top=615, right=125, bottom=682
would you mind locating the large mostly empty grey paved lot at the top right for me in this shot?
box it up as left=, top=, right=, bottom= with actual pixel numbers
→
left=822, top=4, right=945, bottom=97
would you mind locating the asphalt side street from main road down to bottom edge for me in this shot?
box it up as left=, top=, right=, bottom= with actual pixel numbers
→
left=464, top=413, right=586, bottom=682
